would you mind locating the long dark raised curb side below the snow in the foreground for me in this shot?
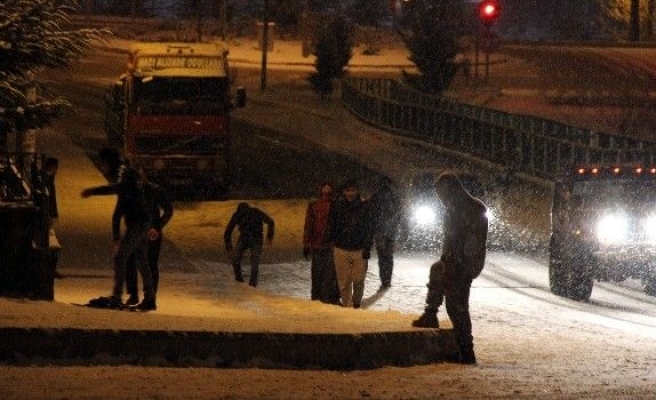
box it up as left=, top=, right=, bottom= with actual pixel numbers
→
left=0, top=328, right=457, bottom=370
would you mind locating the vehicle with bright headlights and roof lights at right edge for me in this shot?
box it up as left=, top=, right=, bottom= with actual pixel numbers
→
left=549, top=165, right=656, bottom=300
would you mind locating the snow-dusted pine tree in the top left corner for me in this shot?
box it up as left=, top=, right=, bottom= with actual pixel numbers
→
left=0, top=0, right=108, bottom=147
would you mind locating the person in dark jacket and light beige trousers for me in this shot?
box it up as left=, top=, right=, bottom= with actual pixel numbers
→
left=326, top=180, right=372, bottom=308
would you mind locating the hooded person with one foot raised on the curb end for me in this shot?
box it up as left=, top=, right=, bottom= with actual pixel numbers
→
left=412, top=172, right=488, bottom=364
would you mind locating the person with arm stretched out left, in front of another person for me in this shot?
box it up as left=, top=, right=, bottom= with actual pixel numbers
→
left=82, top=147, right=157, bottom=311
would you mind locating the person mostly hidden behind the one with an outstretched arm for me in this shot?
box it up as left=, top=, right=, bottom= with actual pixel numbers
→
left=126, top=170, right=173, bottom=305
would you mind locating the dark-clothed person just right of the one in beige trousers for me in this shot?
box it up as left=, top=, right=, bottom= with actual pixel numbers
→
left=369, top=177, right=401, bottom=290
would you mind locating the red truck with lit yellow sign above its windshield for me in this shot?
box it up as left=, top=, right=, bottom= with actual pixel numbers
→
left=105, top=42, right=246, bottom=195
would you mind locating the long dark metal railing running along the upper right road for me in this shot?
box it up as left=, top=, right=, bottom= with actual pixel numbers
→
left=342, top=78, right=656, bottom=178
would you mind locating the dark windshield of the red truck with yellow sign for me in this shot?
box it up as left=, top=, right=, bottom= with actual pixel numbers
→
left=134, top=77, right=230, bottom=115
